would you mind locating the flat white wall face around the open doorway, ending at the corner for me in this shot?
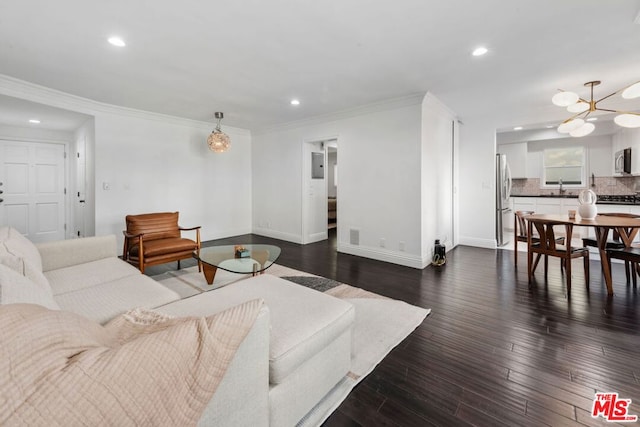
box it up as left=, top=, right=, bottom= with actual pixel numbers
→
left=252, top=96, right=423, bottom=267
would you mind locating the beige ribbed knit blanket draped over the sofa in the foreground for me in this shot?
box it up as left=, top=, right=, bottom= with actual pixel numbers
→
left=0, top=300, right=263, bottom=426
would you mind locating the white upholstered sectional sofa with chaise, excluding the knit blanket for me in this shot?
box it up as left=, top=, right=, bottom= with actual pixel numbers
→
left=0, top=227, right=355, bottom=426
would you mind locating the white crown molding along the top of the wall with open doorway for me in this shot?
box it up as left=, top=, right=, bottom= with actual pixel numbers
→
left=253, top=92, right=426, bottom=135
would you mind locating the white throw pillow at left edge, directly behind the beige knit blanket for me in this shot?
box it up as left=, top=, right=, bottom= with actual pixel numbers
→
left=0, top=264, right=60, bottom=310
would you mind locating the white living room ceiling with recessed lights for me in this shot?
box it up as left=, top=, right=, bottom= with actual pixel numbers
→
left=0, top=0, right=640, bottom=129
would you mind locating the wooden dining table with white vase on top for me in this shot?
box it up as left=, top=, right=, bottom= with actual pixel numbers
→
left=527, top=214, right=640, bottom=295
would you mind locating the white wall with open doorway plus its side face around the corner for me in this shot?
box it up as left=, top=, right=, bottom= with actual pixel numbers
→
left=253, top=95, right=457, bottom=268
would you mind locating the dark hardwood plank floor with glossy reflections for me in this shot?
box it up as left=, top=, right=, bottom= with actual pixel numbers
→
left=148, top=231, right=640, bottom=426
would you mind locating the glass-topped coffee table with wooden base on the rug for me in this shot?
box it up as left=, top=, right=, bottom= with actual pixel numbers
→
left=193, top=244, right=280, bottom=285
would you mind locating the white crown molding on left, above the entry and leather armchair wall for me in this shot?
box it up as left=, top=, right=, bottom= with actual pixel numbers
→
left=0, top=74, right=251, bottom=136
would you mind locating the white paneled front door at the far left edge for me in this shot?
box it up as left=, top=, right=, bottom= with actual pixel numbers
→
left=0, top=141, right=65, bottom=242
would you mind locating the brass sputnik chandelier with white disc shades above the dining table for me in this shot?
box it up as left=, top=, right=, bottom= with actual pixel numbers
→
left=551, top=80, right=640, bottom=137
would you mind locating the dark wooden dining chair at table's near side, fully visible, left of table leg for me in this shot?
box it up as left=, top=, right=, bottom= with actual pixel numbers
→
left=527, top=218, right=589, bottom=295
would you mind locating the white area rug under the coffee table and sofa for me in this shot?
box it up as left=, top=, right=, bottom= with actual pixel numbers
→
left=153, top=264, right=431, bottom=427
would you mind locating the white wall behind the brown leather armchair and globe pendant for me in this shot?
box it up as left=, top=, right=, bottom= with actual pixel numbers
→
left=95, top=113, right=251, bottom=246
